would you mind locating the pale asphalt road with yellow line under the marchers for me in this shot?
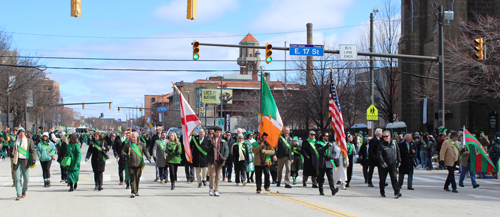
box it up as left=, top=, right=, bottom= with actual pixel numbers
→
left=0, top=145, right=500, bottom=217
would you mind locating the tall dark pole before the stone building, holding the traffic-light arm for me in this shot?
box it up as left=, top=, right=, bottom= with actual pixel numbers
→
left=438, top=5, right=445, bottom=127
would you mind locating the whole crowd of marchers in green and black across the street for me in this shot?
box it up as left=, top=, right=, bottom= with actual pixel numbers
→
left=0, top=126, right=500, bottom=200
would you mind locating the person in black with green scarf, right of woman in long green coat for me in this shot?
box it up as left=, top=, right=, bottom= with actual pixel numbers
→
left=85, top=132, right=109, bottom=191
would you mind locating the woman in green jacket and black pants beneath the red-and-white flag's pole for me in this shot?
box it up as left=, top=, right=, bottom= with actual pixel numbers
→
left=165, top=132, right=182, bottom=190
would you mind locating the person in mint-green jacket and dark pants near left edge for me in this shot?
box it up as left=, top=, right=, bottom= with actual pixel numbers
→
left=36, top=132, right=56, bottom=187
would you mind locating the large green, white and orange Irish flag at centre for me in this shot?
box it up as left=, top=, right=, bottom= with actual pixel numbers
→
left=259, top=73, right=283, bottom=148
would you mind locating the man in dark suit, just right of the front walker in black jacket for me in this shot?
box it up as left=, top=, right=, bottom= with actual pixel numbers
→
left=398, top=134, right=415, bottom=190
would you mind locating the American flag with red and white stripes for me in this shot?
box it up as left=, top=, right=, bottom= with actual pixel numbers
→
left=328, top=69, right=347, bottom=156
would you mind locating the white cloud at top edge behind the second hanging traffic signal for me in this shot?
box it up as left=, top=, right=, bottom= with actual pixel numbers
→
left=154, top=0, right=239, bottom=21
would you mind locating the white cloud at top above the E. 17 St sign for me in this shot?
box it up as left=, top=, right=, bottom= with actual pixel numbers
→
left=250, top=0, right=354, bottom=31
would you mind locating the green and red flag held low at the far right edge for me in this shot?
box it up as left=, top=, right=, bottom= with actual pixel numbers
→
left=463, top=126, right=498, bottom=172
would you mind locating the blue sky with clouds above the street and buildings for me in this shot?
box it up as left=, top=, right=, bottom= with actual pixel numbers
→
left=0, top=0, right=390, bottom=119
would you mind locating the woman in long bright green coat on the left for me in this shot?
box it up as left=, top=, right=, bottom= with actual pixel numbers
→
left=64, top=133, right=82, bottom=192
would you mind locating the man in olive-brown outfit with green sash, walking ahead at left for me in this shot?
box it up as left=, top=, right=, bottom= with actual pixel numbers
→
left=122, top=132, right=151, bottom=198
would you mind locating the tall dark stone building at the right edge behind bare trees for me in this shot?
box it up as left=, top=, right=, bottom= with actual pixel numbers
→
left=398, top=0, right=500, bottom=132
